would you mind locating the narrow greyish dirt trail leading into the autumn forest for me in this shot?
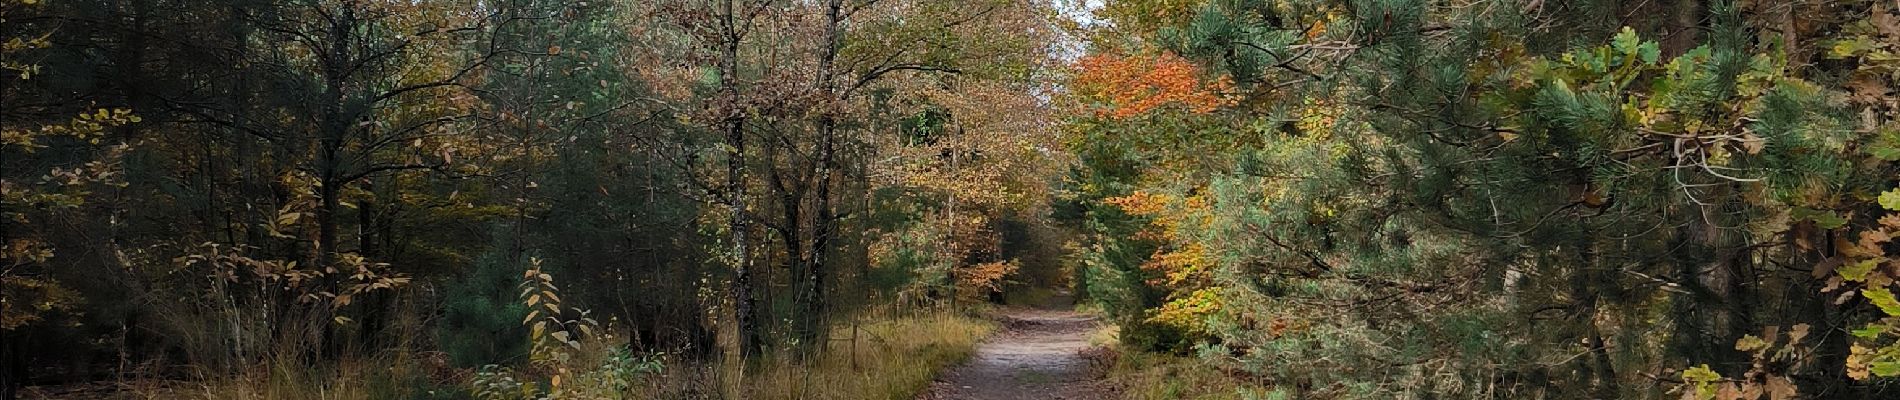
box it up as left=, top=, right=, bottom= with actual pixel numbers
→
left=920, top=309, right=1112, bottom=400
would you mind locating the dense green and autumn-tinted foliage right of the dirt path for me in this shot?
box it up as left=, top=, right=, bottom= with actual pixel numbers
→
left=1064, top=0, right=1900, bottom=398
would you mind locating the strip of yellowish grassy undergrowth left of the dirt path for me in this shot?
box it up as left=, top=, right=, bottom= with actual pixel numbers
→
left=70, top=313, right=996, bottom=400
